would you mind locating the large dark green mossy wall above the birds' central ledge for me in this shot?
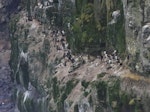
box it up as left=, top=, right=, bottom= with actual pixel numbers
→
left=63, top=0, right=126, bottom=56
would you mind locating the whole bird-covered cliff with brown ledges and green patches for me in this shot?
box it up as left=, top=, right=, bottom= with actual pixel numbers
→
left=9, top=0, right=150, bottom=112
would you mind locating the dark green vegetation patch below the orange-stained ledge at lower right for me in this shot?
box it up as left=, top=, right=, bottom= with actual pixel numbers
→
left=95, top=77, right=143, bottom=112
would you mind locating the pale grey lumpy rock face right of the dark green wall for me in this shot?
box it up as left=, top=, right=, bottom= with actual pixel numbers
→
left=123, top=0, right=150, bottom=75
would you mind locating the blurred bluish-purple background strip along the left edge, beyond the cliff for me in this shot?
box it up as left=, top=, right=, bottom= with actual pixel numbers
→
left=0, top=0, right=18, bottom=112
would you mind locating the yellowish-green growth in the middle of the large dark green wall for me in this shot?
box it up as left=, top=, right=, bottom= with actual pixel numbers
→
left=69, top=3, right=104, bottom=53
